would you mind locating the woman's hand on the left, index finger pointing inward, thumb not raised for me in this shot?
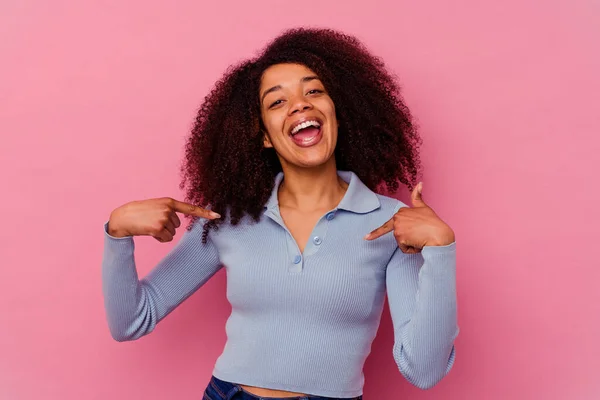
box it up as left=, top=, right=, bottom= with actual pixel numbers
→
left=108, top=197, right=221, bottom=242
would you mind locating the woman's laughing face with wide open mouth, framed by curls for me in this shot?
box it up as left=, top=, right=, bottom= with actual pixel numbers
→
left=259, top=64, right=338, bottom=167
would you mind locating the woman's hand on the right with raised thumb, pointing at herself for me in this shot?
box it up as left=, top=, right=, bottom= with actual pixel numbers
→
left=365, top=182, right=454, bottom=253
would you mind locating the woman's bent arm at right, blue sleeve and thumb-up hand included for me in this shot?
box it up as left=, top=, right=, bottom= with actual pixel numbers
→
left=365, top=184, right=459, bottom=389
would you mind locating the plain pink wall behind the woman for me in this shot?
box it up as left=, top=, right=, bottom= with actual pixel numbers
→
left=0, top=0, right=600, bottom=400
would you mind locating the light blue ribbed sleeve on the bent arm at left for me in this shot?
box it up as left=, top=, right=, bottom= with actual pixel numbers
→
left=102, top=221, right=222, bottom=342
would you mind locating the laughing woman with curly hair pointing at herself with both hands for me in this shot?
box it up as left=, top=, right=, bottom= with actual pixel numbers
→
left=102, top=29, right=459, bottom=400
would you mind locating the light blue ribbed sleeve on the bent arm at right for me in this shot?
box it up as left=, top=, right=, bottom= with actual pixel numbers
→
left=386, top=242, right=459, bottom=389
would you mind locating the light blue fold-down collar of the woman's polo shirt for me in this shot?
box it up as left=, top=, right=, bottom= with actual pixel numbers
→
left=265, top=170, right=381, bottom=214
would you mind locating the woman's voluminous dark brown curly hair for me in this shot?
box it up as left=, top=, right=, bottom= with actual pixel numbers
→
left=180, top=28, right=422, bottom=242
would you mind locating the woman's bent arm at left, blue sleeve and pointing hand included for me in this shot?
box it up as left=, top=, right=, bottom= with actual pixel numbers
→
left=102, top=199, right=221, bottom=342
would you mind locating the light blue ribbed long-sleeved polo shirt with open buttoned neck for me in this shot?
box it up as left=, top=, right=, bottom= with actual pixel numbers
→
left=102, top=171, right=459, bottom=398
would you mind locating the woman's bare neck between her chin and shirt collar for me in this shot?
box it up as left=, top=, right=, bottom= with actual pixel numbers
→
left=278, top=160, right=348, bottom=212
